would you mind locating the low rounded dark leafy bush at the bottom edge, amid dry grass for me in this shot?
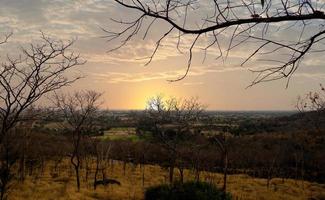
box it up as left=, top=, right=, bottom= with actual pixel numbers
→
left=145, top=182, right=231, bottom=200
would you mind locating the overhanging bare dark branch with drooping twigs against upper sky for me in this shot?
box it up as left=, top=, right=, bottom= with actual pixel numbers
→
left=104, top=0, right=325, bottom=85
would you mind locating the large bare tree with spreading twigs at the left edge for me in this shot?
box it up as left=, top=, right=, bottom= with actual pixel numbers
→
left=0, top=34, right=84, bottom=199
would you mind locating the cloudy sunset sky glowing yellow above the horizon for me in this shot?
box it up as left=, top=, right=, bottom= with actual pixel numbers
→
left=0, top=0, right=325, bottom=110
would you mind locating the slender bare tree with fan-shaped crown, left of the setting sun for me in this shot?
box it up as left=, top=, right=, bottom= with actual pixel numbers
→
left=53, top=90, right=102, bottom=191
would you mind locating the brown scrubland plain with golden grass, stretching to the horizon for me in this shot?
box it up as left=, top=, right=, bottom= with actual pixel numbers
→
left=7, top=113, right=325, bottom=200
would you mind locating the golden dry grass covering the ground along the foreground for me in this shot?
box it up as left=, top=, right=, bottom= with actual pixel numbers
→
left=9, top=161, right=325, bottom=200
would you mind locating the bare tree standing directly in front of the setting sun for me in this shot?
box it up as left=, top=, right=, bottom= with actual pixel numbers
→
left=142, top=96, right=204, bottom=183
